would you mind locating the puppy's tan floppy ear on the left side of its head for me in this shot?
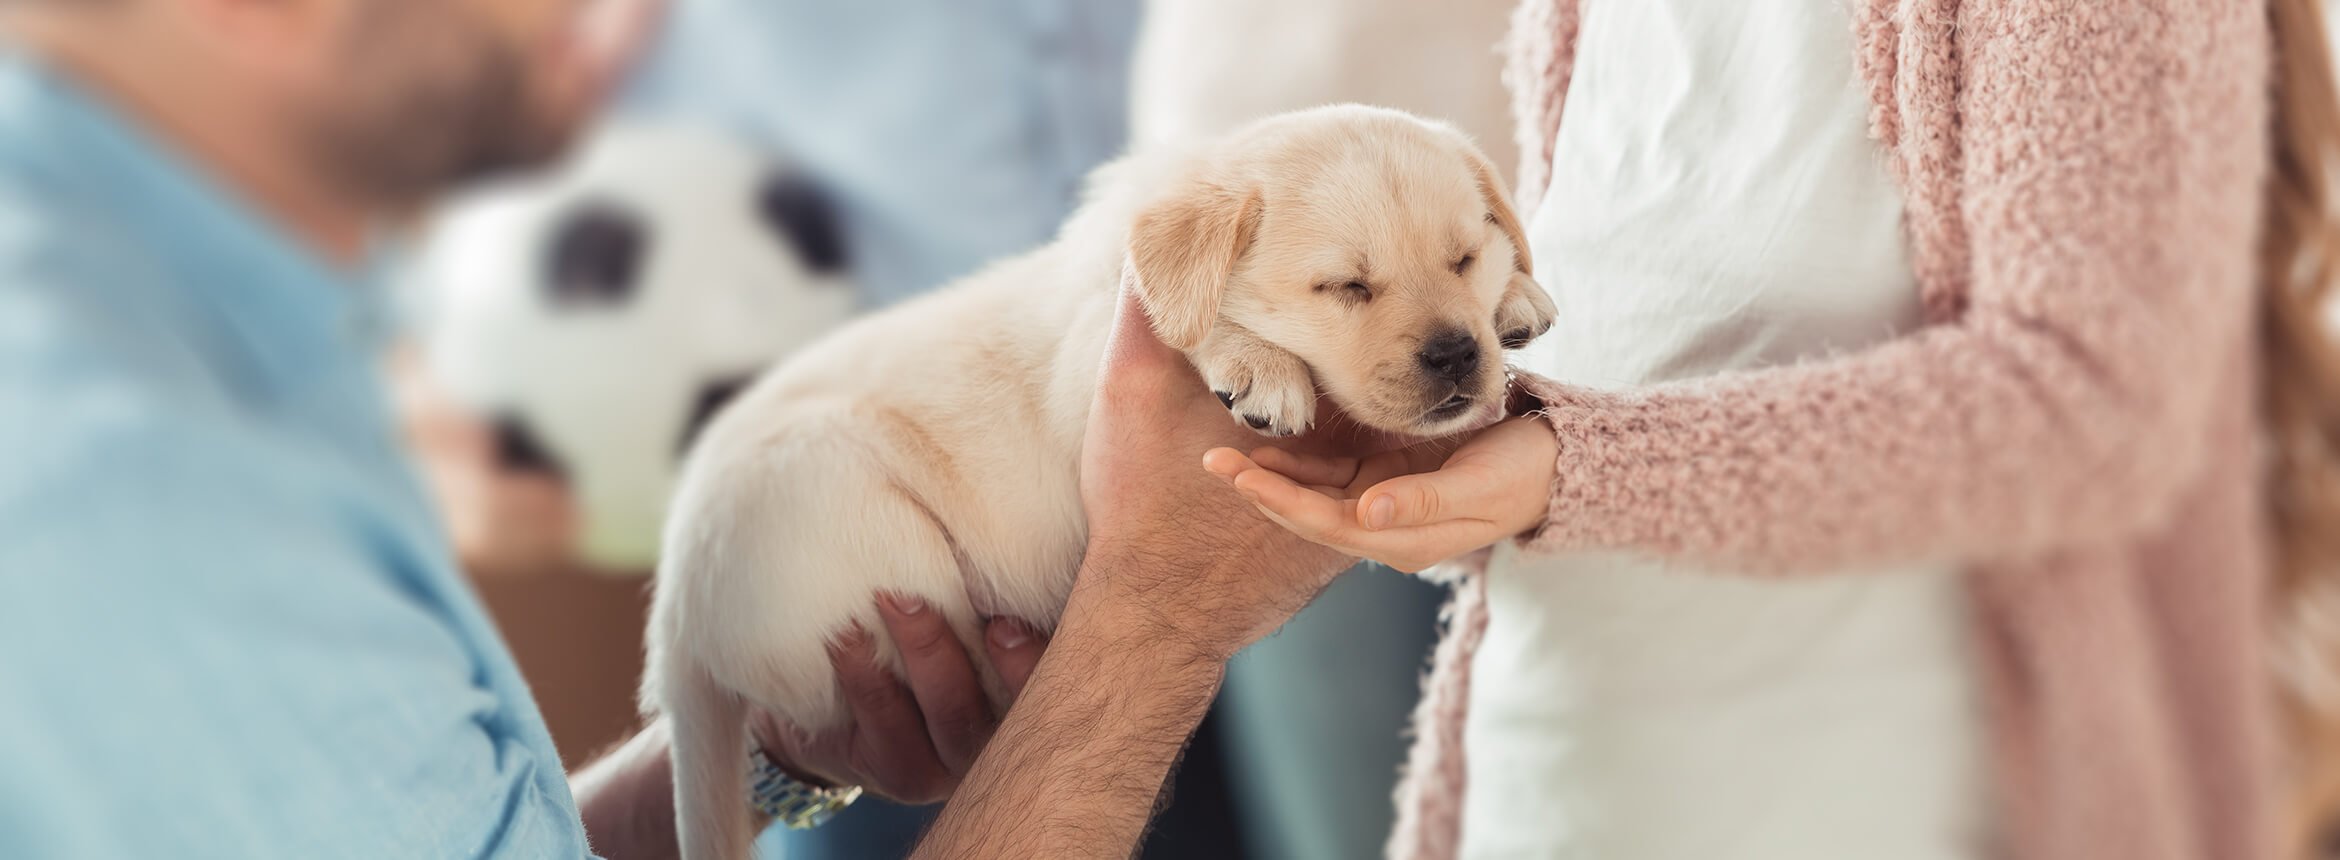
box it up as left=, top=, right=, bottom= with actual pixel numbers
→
left=1130, top=180, right=1261, bottom=351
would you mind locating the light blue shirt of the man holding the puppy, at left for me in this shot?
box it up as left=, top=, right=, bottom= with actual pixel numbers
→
left=0, top=54, right=585, bottom=858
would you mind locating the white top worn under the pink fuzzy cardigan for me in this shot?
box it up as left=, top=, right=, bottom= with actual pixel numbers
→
left=1463, top=0, right=1987, bottom=860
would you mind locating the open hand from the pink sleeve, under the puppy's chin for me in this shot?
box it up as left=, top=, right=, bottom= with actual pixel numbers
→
left=1203, top=416, right=1561, bottom=573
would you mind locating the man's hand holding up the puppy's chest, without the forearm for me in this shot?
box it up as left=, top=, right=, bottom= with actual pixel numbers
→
left=1076, top=290, right=1367, bottom=661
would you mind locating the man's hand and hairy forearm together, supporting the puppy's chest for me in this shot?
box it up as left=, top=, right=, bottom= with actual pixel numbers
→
left=917, top=292, right=1374, bottom=860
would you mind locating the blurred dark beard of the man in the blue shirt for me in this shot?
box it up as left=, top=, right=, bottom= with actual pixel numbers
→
left=297, top=0, right=571, bottom=213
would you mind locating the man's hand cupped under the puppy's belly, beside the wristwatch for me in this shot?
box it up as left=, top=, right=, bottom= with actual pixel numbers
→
left=751, top=596, right=1048, bottom=804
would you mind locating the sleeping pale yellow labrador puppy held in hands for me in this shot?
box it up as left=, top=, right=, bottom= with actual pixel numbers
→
left=644, top=105, right=1554, bottom=860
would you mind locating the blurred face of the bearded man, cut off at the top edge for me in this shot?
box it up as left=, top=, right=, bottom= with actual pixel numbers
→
left=290, top=0, right=636, bottom=210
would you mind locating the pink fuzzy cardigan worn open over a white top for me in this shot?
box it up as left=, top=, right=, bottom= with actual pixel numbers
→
left=1390, top=0, right=2277, bottom=860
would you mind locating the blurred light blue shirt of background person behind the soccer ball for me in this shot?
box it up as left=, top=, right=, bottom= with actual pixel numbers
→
left=622, top=0, right=1140, bottom=306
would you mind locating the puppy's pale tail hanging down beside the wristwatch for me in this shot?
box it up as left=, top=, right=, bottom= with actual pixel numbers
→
left=667, top=666, right=756, bottom=860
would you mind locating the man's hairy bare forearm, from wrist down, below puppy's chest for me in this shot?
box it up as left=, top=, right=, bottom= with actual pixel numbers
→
left=917, top=573, right=1226, bottom=858
